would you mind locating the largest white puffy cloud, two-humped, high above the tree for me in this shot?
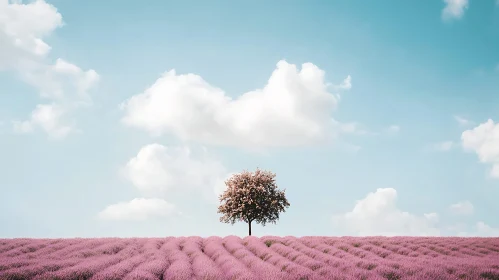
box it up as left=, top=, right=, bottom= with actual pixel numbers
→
left=121, top=61, right=351, bottom=149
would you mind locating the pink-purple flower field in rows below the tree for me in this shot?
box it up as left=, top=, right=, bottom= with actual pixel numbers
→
left=0, top=236, right=499, bottom=280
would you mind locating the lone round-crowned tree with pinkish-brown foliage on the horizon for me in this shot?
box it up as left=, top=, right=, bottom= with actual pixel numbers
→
left=218, top=169, right=290, bottom=235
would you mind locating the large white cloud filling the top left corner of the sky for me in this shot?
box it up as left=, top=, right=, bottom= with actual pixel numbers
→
left=0, top=0, right=99, bottom=98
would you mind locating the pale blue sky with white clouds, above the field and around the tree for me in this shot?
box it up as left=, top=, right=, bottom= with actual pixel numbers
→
left=0, top=0, right=499, bottom=238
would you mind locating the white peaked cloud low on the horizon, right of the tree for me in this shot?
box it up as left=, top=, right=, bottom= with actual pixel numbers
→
left=332, top=188, right=440, bottom=236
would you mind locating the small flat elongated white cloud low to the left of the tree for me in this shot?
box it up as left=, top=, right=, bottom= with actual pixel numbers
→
left=98, top=198, right=175, bottom=220
